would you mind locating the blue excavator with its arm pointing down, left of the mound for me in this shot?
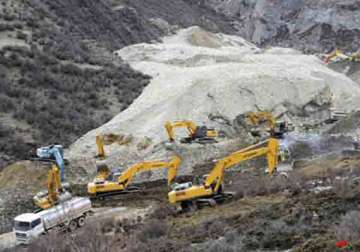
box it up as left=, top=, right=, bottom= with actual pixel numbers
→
left=34, top=144, right=65, bottom=181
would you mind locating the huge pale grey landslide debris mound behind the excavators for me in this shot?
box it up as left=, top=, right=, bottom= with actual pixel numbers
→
left=67, top=27, right=360, bottom=183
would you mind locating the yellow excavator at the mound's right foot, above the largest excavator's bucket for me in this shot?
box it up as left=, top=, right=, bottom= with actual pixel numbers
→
left=245, top=111, right=293, bottom=138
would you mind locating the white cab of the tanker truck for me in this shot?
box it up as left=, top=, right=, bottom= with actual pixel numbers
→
left=14, top=213, right=45, bottom=244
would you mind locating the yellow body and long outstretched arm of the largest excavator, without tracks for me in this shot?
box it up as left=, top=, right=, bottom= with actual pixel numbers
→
left=168, top=138, right=279, bottom=203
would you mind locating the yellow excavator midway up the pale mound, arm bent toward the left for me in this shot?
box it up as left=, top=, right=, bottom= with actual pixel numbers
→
left=164, top=121, right=220, bottom=143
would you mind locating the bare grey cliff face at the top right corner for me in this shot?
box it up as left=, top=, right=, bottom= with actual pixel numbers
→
left=204, top=0, right=360, bottom=52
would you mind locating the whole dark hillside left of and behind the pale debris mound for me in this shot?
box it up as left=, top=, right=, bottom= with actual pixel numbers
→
left=0, top=0, right=359, bottom=167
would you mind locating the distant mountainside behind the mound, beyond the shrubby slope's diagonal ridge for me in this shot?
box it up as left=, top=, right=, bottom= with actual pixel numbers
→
left=119, top=0, right=360, bottom=53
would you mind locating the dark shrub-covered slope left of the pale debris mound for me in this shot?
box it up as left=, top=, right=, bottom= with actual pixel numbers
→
left=0, top=0, right=158, bottom=168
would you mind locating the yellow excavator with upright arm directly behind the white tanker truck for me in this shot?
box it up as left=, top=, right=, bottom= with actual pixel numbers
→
left=33, top=163, right=72, bottom=209
